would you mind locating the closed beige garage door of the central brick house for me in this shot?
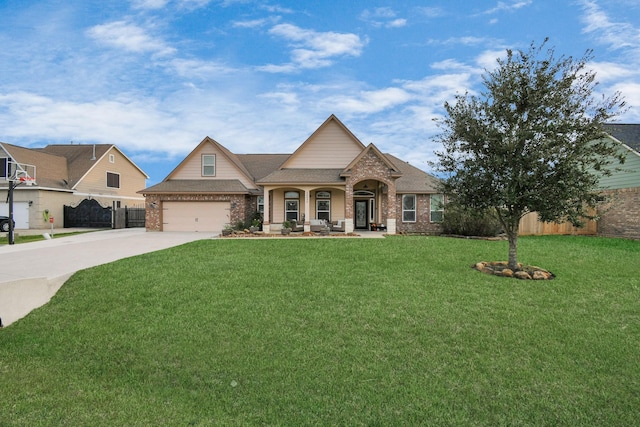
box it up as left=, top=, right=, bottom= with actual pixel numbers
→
left=162, top=202, right=231, bottom=232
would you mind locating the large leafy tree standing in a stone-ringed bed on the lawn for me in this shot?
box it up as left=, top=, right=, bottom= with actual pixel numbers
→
left=436, top=40, right=625, bottom=269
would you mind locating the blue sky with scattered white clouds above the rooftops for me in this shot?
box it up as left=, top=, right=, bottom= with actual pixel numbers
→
left=0, top=0, right=640, bottom=186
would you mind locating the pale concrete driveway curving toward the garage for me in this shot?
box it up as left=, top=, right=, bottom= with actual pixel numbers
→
left=0, top=228, right=218, bottom=326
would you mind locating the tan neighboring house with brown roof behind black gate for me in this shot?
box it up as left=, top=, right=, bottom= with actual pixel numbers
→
left=0, top=143, right=149, bottom=229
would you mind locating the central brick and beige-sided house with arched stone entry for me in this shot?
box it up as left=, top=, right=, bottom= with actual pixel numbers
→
left=140, top=115, right=443, bottom=234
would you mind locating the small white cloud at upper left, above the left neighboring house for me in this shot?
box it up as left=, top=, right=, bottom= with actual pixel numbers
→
left=87, top=21, right=175, bottom=55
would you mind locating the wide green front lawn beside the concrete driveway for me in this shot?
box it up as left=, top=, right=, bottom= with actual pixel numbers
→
left=0, top=236, right=640, bottom=426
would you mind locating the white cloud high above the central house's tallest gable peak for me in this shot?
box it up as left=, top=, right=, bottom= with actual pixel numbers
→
left=260, top=24, right=366, bottom=72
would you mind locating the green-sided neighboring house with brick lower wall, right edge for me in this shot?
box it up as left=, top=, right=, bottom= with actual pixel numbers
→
left=598, top=124, right=640, bottom=239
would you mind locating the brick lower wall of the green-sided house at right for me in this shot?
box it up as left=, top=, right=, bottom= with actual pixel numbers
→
left=598, top=187, right=640, bottom=239
